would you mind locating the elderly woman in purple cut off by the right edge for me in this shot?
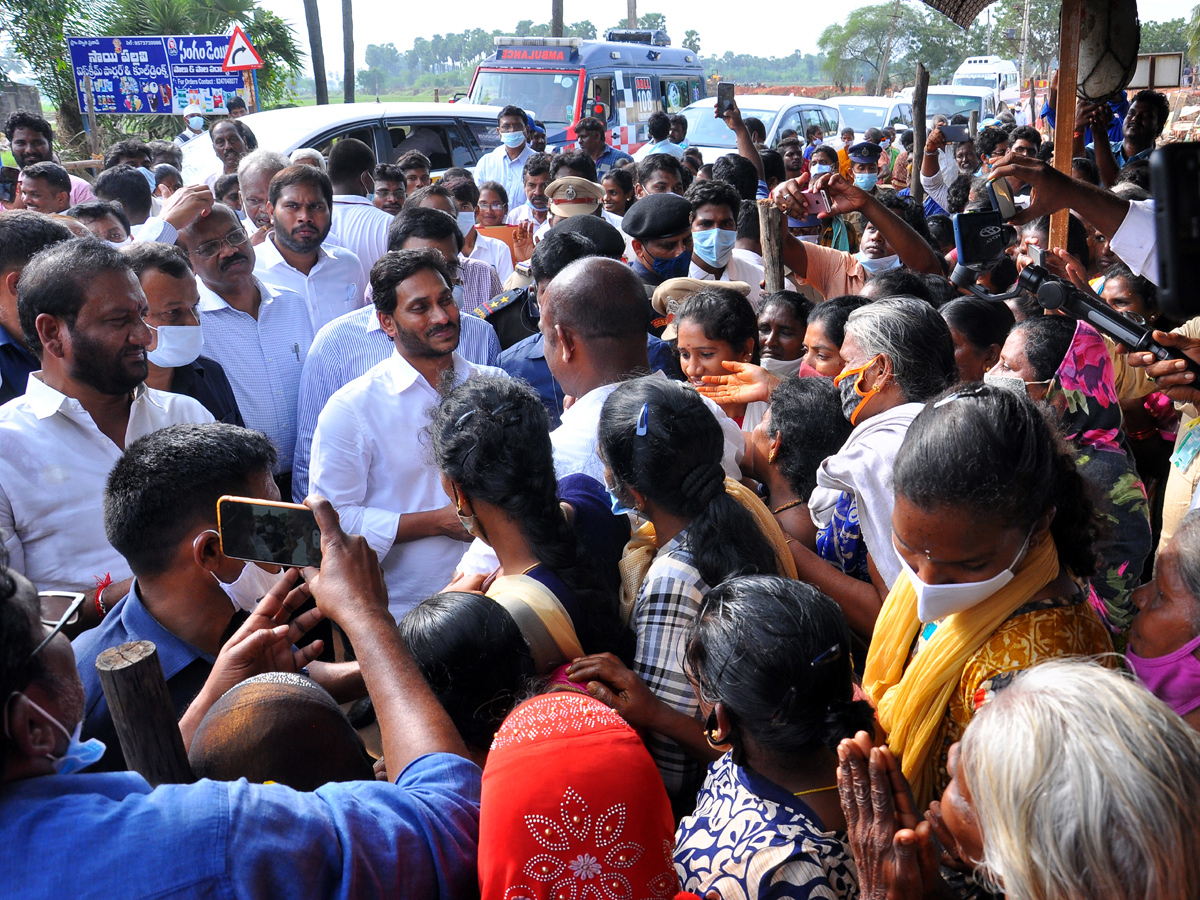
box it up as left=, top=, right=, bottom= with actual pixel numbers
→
left=1126, top=511, right=1200, bottom=731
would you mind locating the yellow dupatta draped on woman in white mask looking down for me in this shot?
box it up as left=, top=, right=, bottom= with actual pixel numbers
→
left=863, top=535, right=1060, bottom=806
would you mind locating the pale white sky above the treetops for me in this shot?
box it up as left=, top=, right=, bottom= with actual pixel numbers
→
left=260, top=0, right=1195, bottom=79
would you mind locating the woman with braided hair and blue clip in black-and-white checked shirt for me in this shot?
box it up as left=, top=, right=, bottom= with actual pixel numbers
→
left=568, top=376, right=779, bottom=812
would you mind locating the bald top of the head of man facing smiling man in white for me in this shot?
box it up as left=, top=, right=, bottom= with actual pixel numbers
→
left=541, top=257, right=650, bottom=347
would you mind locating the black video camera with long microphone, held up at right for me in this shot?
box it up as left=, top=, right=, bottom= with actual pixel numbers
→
left=950, top=210, right=1200, bottom=378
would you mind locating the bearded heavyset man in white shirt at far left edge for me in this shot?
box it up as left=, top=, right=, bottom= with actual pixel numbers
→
left=0, top=240, right=212, bottom=624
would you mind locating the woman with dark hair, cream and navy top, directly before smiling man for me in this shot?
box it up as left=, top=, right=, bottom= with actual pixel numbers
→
left=428, top=377, right=632, bottom=676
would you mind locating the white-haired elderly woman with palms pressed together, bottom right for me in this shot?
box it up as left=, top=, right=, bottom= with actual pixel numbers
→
left=838, top=660, right=1200, bottom=900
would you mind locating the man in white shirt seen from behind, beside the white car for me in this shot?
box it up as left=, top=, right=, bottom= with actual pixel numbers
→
left=329, top=138, right=391, bottom=282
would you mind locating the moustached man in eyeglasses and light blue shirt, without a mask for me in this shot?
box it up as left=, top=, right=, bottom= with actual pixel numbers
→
left=179, top=203, right=313, bottom=508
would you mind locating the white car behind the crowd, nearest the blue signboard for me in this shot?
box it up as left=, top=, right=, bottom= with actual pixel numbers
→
left=184, top=103, right=500, bottom=184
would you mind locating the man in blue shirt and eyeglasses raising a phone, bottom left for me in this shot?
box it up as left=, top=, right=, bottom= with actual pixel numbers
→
left=0, top=498, right=480, bottom=900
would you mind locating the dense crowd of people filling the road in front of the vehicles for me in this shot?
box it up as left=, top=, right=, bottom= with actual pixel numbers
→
left=0, top=91, right=1200, bottom=900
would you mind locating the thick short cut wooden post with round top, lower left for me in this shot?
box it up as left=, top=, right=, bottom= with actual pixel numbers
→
left=96, top=641, right=196, bottom=786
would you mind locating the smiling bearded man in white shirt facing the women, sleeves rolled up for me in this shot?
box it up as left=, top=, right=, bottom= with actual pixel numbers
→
left=310, top=250, right=502, bottom=620
